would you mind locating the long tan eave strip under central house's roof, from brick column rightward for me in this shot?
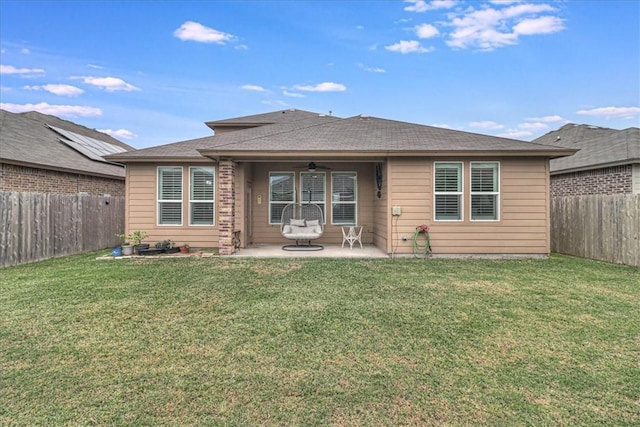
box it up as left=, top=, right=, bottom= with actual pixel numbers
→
left=198, top=149, right=577, bottom=161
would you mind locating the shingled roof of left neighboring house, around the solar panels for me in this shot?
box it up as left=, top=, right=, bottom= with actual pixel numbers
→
left=0, top=110, right=134, bottom=179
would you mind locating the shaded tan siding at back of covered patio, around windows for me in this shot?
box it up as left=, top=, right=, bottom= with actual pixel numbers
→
left=250, top=162, right=376, bottom=244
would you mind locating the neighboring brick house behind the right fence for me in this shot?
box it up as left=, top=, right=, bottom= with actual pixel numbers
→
left=533, top=123, right=640, bottom=196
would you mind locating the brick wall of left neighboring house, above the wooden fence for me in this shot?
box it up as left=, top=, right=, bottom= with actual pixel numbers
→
left=0, top=163, right=125, bottom=196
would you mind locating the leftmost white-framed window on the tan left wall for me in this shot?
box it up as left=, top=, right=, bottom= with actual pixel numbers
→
left=158, top=167, right=182, bottom=225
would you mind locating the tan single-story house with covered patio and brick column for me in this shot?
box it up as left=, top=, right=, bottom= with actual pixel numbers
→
left=107, top=110, right=576, bottom=256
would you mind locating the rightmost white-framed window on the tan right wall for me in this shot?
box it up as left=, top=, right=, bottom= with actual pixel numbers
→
left=471, top=162, right=500, bottom=221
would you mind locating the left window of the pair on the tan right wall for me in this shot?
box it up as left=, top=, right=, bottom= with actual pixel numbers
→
left=434, top=162, right=462, bottom=221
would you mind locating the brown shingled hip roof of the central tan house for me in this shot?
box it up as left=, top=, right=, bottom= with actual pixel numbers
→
left=108, top=110, right=575, bottom=163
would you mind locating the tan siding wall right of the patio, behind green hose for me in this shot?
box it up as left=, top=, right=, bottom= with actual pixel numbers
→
left=387, top=158, right=549, bottom=254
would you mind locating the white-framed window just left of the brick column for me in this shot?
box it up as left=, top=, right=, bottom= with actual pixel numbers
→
left=189, top=167, right=215, bottom=225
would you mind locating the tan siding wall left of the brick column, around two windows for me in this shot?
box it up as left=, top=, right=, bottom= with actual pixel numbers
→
left=125, top=163, right=218, bottom=248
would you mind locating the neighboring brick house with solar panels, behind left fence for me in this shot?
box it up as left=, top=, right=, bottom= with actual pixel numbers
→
left=0, top=110, right=134, bottom=196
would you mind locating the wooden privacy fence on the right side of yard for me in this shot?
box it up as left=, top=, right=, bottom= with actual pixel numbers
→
left=551, top=194, right=640, bottom=266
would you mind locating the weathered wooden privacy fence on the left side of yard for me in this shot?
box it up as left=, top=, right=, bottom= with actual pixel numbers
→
left=0, top=191, right=124, bottom=267
